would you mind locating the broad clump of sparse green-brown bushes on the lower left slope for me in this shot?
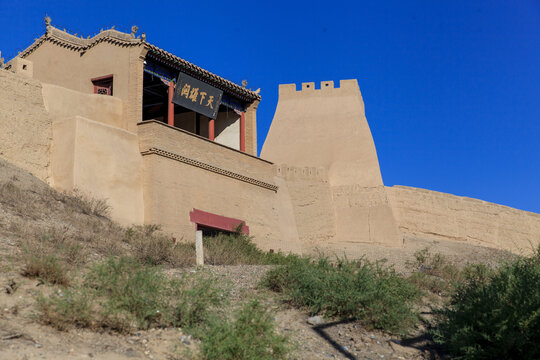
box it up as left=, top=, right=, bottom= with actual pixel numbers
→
left=38, top=257, right=226, bottom=333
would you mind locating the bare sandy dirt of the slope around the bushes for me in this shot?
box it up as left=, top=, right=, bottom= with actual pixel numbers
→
left=0, top=160, right=508, bottom=359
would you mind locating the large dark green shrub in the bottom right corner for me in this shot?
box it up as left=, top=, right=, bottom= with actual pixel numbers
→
left=433, top=248, right=540, bottom=359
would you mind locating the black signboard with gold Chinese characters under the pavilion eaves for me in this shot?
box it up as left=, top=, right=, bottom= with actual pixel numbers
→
left=173, top=73, right=223, bottom=119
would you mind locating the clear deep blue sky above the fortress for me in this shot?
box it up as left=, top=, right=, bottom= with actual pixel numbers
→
left=0, top=0, right=540, bottom=213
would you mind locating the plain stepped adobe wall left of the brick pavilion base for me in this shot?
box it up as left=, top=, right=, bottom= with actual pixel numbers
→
left=0, top=67, right=144, bottom=224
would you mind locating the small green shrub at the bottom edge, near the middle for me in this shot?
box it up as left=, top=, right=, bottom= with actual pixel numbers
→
left=201, top=300, right=289, bottom=360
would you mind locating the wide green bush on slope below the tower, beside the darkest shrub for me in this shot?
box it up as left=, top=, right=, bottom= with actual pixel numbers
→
left=262, top=257, right=420, bottom=333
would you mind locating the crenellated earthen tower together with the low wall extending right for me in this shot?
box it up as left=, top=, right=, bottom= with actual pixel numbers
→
left=261, top=80, right=540, bottom=254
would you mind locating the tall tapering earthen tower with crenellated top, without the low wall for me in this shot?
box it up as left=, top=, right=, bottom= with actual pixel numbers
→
left=261, top=80, right=402, bottom=247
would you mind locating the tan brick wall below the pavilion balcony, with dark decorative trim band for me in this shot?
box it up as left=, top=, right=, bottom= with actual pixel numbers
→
left=138, top=121, right=280, bottom=250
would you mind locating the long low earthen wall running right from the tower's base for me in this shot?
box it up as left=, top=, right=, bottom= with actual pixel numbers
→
left=387, top=186, right=540, bottom=254
